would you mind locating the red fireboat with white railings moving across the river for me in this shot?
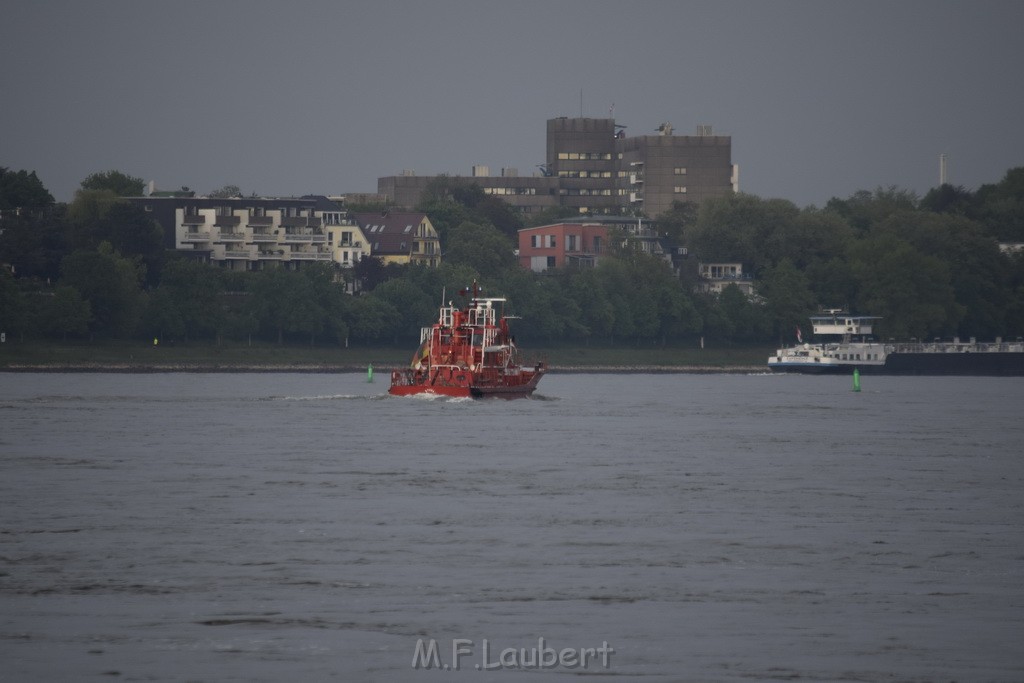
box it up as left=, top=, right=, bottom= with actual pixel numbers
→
left=388, top=282, right=547, bottom=398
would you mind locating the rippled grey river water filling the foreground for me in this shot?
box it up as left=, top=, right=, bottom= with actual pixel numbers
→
left=0, top=374, right=1024, bottom=682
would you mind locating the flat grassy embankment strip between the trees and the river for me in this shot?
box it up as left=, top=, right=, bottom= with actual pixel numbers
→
left=0, top=336, right=771, bottom=372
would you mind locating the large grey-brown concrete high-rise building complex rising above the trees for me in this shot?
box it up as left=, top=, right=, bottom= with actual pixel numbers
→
left=377, top=117, right=738, bottom=218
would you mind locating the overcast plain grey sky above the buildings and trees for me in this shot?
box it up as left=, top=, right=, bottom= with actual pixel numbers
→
left=0, top=0, right=1024, bottom=206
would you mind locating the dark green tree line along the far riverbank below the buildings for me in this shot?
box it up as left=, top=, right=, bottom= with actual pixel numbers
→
left=0, top=163, right=1024, bottom=345
